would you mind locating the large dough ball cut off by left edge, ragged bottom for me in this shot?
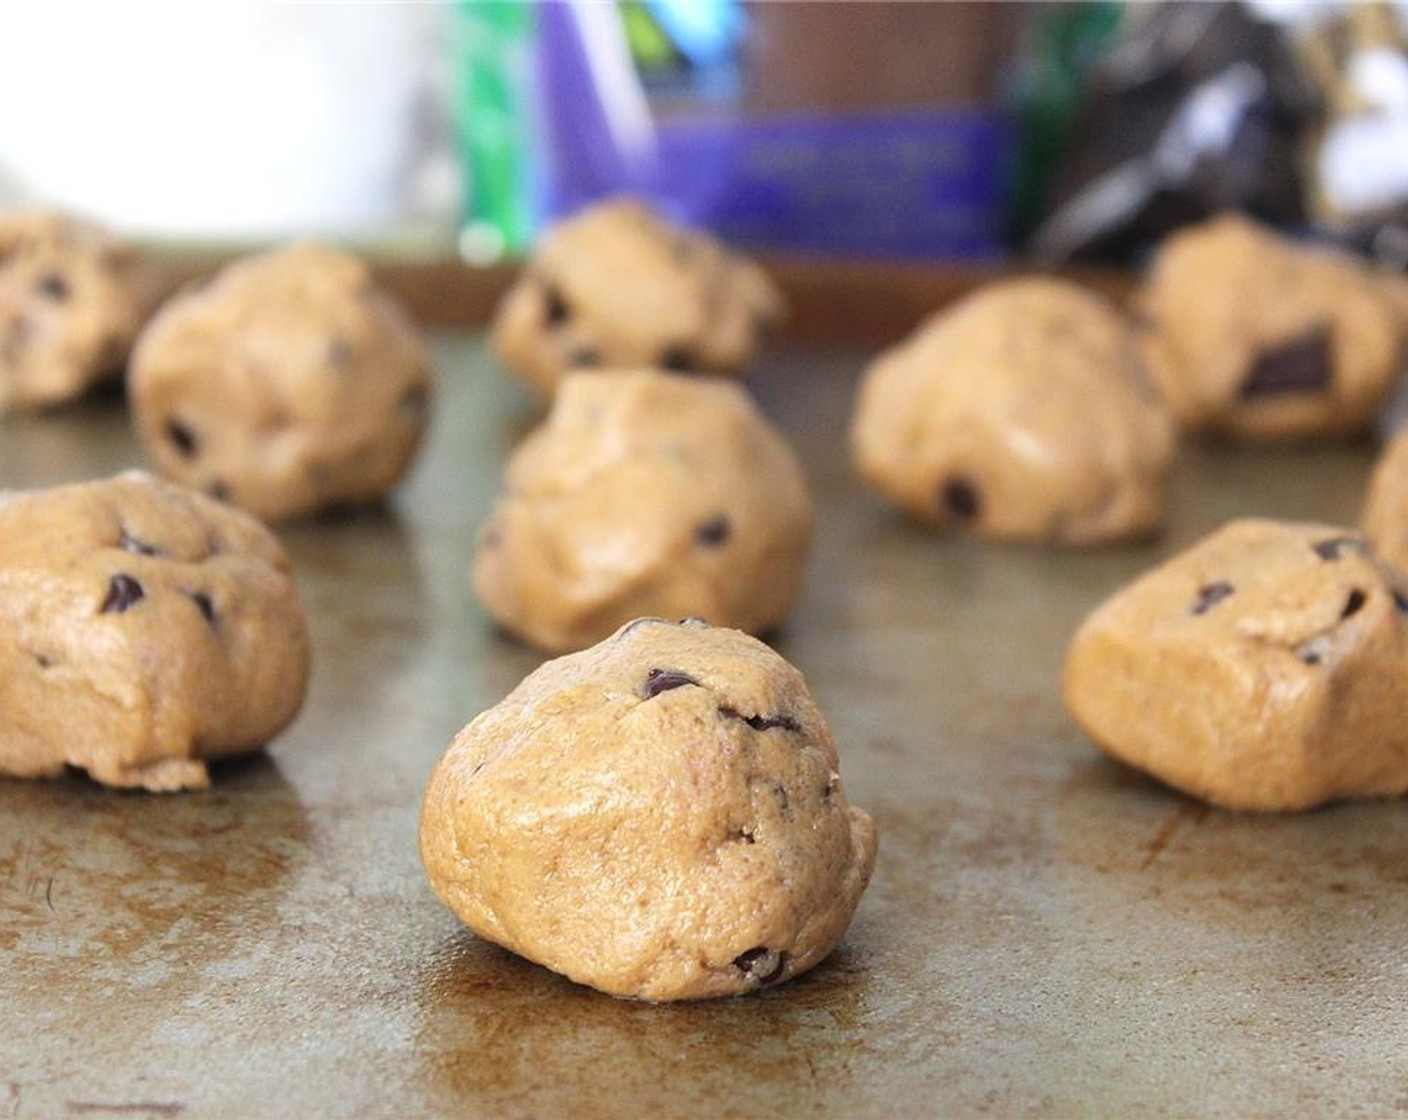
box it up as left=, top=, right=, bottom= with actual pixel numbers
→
left=0, top=471, right=308, bottom=792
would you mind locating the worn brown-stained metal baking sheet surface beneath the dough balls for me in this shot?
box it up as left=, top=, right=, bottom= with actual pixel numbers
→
left=0, top=337, right=1408, bottom=1120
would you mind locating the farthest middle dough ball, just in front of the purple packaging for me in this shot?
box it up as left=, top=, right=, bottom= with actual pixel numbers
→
left=493, top=199, right=783, bottom=396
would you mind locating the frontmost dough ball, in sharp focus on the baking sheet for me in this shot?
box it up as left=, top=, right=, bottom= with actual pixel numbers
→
left=421, top=618, right=876, bottom=1000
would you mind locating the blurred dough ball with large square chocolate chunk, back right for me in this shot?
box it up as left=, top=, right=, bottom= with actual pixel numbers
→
left=1138, top=216, right=1404, bottom=440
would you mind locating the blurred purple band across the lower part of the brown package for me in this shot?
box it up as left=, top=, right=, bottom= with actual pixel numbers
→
left=551, top=110, right=1012, bottom=259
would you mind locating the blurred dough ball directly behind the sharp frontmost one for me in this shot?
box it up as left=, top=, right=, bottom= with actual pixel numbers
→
left=473, top=371, right=811, bottom=652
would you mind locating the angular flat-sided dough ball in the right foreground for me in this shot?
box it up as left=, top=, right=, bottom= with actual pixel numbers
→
left=1066, top=520, right=1408, bottom=810
